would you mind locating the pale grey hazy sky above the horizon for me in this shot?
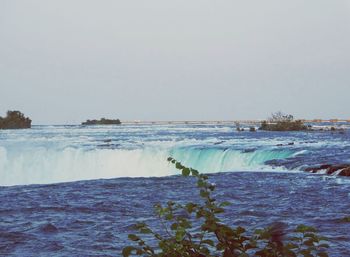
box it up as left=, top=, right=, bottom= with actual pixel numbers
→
left=0, top=0, right=350, bottom=124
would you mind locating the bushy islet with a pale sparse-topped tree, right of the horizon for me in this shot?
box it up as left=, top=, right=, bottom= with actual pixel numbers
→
left=260, top=112, right=308, bottom=131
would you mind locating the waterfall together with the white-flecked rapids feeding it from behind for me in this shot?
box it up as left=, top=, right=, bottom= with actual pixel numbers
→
left=0, top=125, right=349, bottom=186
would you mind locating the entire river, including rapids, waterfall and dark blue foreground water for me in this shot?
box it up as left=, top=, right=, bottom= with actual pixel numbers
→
left=0, top=124, right=350, bottom=256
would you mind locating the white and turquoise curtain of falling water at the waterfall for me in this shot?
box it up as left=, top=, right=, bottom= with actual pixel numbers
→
left=0, top=147, right=294, bottom=186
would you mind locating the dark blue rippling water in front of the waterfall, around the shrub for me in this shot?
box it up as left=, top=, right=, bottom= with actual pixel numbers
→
left=0, top=172, right=350, bottom=257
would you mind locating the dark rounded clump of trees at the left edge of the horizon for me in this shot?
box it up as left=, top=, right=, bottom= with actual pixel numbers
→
left=0, top=111, right=32, bottom=129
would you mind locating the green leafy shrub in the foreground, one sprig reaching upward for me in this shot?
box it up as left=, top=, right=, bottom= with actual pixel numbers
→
left=122, top=157, right=328, bottom=257
